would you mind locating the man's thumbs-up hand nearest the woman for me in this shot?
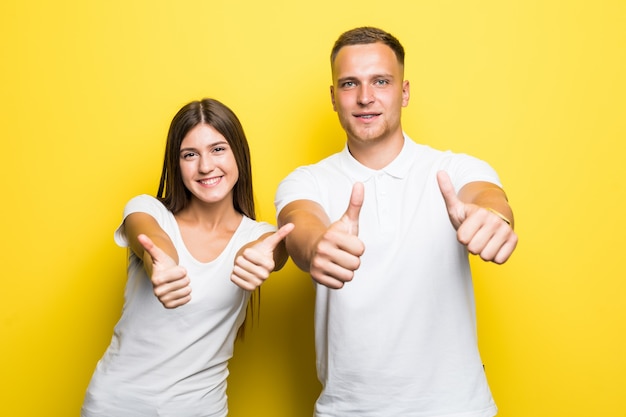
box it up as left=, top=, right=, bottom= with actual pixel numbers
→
left=309, top=183, right=365, bottom=289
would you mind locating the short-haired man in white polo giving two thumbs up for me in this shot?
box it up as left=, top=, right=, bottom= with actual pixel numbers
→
left=276, top=27, right=517, bottom=417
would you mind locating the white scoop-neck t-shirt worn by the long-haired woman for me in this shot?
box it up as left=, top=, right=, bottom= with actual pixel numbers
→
left=81, top=195, right=276, bottom=417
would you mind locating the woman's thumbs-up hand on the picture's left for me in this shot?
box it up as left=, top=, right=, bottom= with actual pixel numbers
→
left=137, top=234, right=191, bottom=308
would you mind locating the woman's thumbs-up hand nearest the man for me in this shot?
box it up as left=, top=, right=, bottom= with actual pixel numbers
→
left=230, top=223, right=294, bottom=291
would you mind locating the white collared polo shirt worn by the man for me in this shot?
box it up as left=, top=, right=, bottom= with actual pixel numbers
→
left=275, top=137, right=500, bottom=417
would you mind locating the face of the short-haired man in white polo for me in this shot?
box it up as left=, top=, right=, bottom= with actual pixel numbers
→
left=330, top=43, right=409, bottom=145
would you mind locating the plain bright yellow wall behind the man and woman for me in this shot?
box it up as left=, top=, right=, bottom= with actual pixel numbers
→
left=0, top=0, right=626, bottom=417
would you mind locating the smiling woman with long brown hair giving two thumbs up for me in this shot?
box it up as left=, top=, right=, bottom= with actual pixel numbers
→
left=81, top=99, right=293, bottom=417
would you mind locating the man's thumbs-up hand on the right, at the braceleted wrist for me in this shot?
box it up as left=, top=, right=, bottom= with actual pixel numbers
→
left=437, top=171, right=517, bottom=264
